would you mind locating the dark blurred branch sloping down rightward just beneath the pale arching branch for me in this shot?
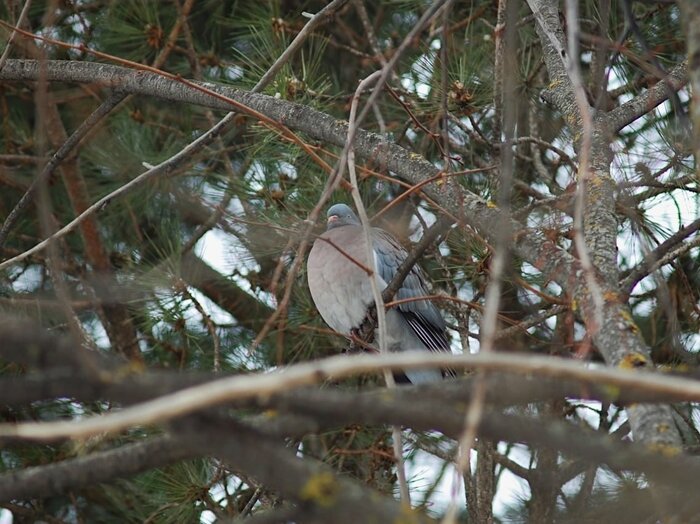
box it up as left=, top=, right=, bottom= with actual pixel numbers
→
left=262, top=388, right=700, bottom=494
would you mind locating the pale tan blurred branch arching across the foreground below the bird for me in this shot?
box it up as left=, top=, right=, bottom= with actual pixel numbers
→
left=6, top=351, right=700, bottom=442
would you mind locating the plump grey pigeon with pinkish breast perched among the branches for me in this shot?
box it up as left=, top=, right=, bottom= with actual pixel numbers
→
left=307, top=204, right=451, bottom=384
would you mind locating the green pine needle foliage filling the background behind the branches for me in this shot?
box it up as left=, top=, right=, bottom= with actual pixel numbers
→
left=0, top=0, right=700, bottom=523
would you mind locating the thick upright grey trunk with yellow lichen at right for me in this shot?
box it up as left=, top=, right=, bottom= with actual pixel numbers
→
left=528, top=0, right=681, bottom=449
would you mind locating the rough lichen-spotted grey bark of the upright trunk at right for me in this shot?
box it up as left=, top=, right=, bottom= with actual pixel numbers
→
left=530, top=0, right=681, bottom=450
